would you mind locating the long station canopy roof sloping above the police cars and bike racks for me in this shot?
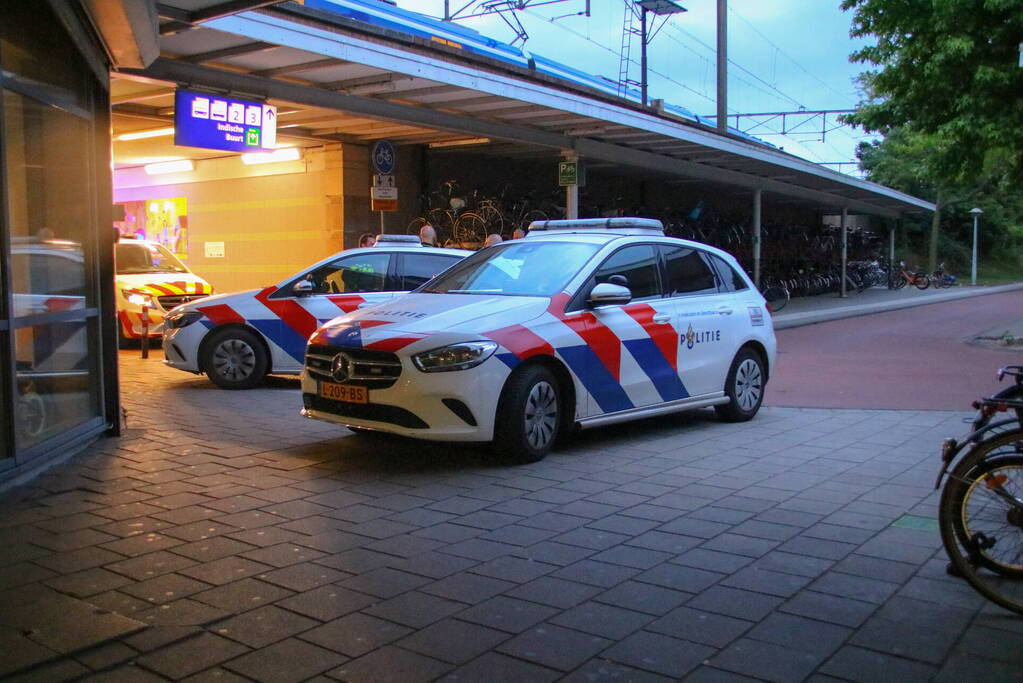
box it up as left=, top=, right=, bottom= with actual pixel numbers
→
left=110, top=0, right=934, bottom=218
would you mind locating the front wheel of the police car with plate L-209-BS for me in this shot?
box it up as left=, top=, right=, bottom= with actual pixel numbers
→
left=494, top=365, right=562, bottom=462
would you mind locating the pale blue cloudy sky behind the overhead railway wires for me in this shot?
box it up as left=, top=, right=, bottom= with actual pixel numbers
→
left=397, top=0, right=874, bottom=174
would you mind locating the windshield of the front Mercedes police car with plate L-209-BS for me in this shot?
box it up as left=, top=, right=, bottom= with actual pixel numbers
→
left=421, top=239, right=601, bottom=297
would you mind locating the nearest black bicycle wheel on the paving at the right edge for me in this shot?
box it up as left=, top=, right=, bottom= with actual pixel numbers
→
left=938, top=429, right=1023, bottom=614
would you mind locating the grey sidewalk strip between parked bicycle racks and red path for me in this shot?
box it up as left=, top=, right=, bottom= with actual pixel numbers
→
left=772, top=282, right=1023, bottom=329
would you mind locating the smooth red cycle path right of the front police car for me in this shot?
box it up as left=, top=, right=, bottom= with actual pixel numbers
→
left=764, top=291, right=1023, bottom=410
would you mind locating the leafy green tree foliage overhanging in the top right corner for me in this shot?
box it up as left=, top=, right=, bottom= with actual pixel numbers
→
left=842, top=0, right=1023, bottom=184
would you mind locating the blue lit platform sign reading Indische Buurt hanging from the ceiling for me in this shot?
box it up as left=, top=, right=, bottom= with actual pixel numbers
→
left=174, top=90, right=277, bottom=152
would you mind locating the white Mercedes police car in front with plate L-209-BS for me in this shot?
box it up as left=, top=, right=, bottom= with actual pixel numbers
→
left=302, top=218, right=775, bottom=461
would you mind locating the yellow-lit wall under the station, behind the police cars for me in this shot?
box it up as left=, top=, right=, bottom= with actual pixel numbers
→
left=114, top=145, right=353, bottom=292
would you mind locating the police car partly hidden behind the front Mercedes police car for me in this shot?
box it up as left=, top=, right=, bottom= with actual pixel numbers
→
left=164, top=235, right=472, bottom=389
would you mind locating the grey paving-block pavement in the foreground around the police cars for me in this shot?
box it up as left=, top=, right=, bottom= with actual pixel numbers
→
left=0, top=352, right=1023, bottom=682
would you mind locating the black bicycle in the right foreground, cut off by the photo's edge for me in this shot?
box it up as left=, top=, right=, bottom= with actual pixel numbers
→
left=935, top=366, right=1023, bottom=614
